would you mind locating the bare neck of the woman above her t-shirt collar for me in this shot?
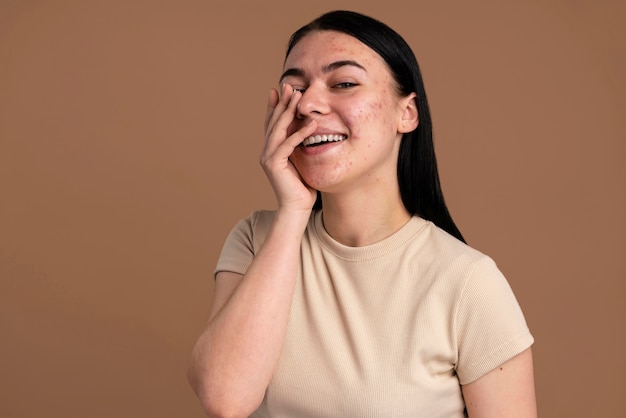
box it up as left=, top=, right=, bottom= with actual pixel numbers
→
left=322, top=192, right=411, bottom=247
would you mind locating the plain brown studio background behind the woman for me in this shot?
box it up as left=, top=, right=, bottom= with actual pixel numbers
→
left=0, top=0, right=626, bottom=418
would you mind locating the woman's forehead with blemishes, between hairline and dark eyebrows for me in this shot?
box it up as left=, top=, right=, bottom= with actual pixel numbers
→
left=285, top=30, right=386, bottom=69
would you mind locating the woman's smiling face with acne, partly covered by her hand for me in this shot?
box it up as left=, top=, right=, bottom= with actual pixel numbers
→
left=281, top=31, right=417, bottom=197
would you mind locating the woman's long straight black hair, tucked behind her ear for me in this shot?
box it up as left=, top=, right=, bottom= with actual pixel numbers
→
left=285, top=10, right=465, bottom=242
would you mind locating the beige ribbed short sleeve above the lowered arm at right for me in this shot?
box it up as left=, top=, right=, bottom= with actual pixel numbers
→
left=456, top=257, right=534, bottom=385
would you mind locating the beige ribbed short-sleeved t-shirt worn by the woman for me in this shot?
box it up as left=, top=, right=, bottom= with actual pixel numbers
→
left=216, top=211, right=533, bottom=418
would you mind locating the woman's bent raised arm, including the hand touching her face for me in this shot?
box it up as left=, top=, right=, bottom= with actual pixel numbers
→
left=184, top=85, right=316, bottom=417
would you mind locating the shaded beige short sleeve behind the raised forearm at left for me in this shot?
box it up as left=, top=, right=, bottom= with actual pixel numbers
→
left=214, top=211, right=274, bottom=276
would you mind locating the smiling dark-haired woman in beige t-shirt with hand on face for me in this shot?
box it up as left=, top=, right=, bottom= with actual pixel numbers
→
left=189, top=11, right=536, bottom=418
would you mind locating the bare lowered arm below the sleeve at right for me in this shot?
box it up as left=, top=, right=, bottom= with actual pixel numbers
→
left=462, top=348, right=537, bottom=418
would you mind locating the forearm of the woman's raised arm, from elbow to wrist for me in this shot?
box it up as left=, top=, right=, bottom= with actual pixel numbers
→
left=190, top=211, right=309, bottom=414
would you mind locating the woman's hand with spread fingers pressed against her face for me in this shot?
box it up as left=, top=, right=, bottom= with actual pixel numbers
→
left=261, top=84, right=317, bottom=211
